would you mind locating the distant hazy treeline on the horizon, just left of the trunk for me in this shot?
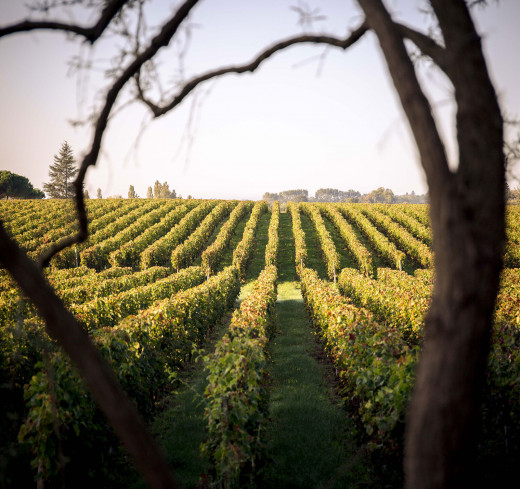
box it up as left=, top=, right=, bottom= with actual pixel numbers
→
left=262, top=187, right=428, bottom=204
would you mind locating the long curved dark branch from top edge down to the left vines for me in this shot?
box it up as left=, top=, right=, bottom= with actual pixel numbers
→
left=39, top=0, right=198, bottom=266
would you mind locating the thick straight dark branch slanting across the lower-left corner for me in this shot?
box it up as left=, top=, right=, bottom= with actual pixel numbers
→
left=0, top=221, right=181, bottom=489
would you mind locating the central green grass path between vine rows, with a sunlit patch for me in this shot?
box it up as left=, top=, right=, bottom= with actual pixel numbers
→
left=257, top=214, right=372, bottom=489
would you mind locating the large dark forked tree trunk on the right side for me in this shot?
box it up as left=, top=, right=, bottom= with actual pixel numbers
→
left=359, top=0, right=505, bottom=489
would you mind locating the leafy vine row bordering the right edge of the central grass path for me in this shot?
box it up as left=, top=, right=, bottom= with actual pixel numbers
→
left=300, top=268, right=418, bottom=451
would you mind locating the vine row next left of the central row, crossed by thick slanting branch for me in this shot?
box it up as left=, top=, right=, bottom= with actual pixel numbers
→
left=19, top=267, right=240, bottom=479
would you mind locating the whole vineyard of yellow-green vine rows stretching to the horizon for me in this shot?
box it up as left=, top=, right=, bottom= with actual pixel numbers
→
left=0, top=199, right=520, bottom=487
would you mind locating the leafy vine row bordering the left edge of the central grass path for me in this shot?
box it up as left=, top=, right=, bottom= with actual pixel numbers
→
left=202, top=265, right=277, bottom=488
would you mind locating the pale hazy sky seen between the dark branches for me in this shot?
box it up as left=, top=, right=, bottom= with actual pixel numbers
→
left=0, top=0, right=520, bottom=199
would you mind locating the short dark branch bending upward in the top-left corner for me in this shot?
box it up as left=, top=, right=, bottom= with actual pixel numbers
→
left=0, top=0, right=127, bottom=44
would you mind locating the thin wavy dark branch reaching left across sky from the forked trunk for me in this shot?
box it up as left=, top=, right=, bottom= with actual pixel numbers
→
left=135, top=23, right=368, bottom=117
